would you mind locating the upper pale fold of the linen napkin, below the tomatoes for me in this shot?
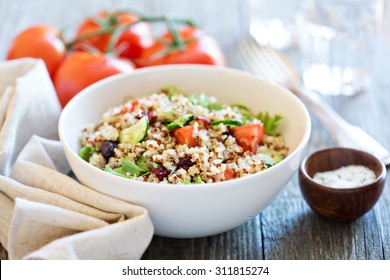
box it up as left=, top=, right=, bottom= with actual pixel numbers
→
left=0, top=59, right=61, bottom=176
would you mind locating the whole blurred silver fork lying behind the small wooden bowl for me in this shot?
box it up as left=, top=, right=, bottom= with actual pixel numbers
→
left=238, top=37, right=390, bottom=165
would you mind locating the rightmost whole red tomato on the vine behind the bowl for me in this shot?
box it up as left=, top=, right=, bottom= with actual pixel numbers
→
left=141, top=26, right=226, bottom=66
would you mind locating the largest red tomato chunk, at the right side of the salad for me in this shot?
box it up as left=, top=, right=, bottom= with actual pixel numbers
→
left=234, top=123, right=265, bottom=153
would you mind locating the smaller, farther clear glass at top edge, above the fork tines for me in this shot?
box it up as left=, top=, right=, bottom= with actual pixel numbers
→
left=249, top=0, right=298, bottom=50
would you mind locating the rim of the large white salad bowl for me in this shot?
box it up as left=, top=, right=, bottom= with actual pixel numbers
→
left=58, top=64, right=311, bottom=191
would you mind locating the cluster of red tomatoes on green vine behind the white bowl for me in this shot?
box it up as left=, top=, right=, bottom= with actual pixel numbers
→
left=6, top=11, right=226, bottom=106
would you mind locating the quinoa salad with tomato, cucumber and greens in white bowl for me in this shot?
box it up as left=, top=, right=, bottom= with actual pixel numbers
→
left=79, top=86, right=288, bottom=184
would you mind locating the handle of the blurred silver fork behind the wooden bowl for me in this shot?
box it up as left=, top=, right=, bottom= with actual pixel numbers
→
left=290, top=84, right=390, bottom=165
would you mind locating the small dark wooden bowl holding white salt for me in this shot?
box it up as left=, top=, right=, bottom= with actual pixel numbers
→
left=299, top=147, right=386, bottom=221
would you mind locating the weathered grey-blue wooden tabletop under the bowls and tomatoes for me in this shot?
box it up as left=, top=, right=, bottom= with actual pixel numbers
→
left=0, top=0, right=390, bottom=260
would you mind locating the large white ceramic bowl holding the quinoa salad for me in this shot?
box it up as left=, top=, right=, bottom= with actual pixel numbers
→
left=59, top=65, right=311, bottom=238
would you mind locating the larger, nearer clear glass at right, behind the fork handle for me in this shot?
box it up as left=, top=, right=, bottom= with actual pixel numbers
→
left=297, top=0, right=385, bottom=95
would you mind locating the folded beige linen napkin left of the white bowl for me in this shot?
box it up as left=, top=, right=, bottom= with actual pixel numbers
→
left=0, top=59, right=153, bottom=259
